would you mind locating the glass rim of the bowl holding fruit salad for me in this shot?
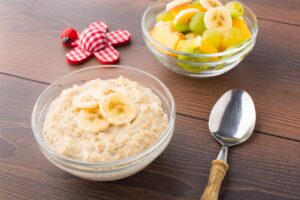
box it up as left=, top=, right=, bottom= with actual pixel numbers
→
left=141, top=0, right=259, bottom=58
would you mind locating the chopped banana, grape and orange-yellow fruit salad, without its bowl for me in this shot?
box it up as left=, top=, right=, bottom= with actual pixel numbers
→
left=149, top=0, right=251, bottom=73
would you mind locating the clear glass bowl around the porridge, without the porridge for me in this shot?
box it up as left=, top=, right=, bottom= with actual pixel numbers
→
left=31, top=65, right=176, bottom=181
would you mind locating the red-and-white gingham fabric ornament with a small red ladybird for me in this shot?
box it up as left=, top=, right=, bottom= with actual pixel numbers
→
left=61, top=21, right=131, bottom=64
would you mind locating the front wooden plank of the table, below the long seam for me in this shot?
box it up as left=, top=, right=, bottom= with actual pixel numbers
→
left=0, top=75, right=300, bottom=200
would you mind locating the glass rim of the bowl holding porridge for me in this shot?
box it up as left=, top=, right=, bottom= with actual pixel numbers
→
left=31, top=65, right=176, bottom=167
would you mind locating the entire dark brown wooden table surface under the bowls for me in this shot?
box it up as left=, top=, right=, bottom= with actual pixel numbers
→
left=0, top=0, right=300, bottom=200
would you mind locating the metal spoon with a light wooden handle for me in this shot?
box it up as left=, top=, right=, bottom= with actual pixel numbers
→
left=201, top=89, right=256, bottom=200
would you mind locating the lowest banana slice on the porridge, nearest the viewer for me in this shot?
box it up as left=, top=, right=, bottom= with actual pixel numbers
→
left=76, top=110, right=109, bottom=132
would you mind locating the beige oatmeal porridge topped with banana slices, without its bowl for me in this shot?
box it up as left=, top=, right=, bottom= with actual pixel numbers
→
left=43, top=77, right=168, bottom=162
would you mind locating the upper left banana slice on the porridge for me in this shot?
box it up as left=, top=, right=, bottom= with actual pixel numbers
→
left=72, top=92, right=99, bottom=110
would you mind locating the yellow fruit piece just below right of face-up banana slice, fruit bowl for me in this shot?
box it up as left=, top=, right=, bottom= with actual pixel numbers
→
left=222, top=27, right=243, bottom=49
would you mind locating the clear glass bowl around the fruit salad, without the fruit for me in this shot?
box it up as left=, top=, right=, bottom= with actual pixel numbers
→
left=142, top=0, right=258, bottom=78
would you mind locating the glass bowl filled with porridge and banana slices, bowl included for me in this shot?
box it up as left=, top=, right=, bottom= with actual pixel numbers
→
left=31, top=65, right=176, bottom=181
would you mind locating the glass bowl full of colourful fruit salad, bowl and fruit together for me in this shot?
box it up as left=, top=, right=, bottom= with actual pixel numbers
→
left=142, top=0, right=258, bottom=77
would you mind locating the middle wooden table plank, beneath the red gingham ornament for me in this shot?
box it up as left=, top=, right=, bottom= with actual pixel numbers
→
left=0, top=0, right=300, bottom=140
